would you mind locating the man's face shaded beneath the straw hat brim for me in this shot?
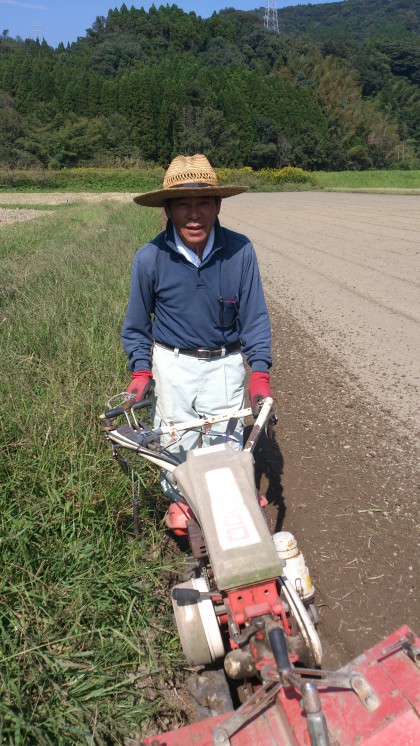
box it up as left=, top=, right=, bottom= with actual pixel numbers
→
left=165, top=197, right=221, bottom=253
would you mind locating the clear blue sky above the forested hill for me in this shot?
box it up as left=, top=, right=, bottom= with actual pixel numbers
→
left=0, top=0, right=344, bottom=47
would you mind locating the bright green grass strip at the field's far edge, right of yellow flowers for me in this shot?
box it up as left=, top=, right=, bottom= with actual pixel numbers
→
left=314, top=171, right=420, bottom=192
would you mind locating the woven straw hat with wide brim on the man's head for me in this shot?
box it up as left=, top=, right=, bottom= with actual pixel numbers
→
left=134, top=153, right=248, bottom=207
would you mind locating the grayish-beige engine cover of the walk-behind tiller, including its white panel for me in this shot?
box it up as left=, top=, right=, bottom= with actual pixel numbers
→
left=173, top=444, right=281, bottom=590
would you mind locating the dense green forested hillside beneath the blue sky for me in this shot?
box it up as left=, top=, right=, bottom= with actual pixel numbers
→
left=0, top=0, right=420, bottom=171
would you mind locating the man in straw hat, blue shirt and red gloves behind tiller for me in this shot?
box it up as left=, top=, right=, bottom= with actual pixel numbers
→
left=122, top=154, right=271, bottom=528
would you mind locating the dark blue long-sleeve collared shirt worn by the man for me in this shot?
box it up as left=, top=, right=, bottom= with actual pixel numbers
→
left=122, top=219, right=271, bottom=372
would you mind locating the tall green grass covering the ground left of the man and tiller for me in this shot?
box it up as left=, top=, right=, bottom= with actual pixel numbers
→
left=0, top=202, right=187, bottom=745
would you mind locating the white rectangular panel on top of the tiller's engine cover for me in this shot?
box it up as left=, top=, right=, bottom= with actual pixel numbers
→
left=205, top=468, right=260, bottom=550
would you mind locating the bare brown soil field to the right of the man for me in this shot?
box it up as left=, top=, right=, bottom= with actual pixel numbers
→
left=225, top=193, right=420, bottom=665
